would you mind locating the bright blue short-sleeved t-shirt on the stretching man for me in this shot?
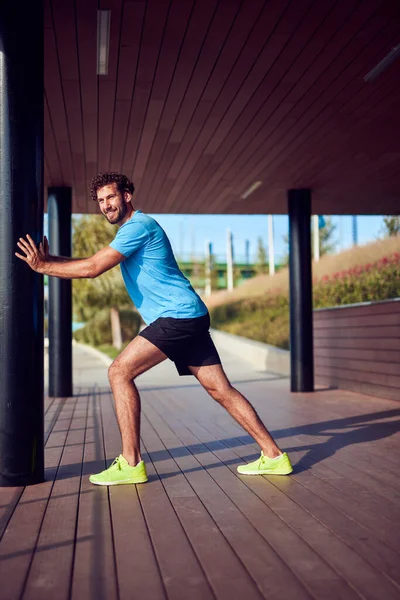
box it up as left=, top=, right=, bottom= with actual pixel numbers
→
left=110, top=210, right=207, bottom=324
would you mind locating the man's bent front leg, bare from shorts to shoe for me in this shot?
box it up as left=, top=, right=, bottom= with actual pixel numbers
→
left=108, top=335, right=167, bottom=467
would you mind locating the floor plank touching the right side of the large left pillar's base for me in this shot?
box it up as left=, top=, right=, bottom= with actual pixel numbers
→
left=0, top=399, right=76, bottom=600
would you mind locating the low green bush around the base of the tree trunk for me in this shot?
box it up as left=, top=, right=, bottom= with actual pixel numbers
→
left=74, top=309, right=141, bottom=347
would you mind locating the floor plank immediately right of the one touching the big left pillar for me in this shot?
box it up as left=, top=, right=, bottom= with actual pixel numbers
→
left=23, top=397, right=89, bottom=600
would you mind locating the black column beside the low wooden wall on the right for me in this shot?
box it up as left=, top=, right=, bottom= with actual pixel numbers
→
left=288, top=190, right=314, bottom=392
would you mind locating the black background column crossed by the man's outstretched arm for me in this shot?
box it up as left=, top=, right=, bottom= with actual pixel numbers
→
left=48, top=188, right=72, bottom=398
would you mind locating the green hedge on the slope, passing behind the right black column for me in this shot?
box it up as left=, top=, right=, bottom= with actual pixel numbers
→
left=210, top=253, right=400, bottom=350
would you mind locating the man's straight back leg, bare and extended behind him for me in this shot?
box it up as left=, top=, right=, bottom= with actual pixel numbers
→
left=189, top=365, right=282, bottom=458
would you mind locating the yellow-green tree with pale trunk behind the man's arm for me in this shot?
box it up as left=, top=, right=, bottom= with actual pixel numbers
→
left=72, top=215, right=130, bottom=348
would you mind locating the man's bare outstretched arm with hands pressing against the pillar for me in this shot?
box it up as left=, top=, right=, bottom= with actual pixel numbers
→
left=15, top=235, right=125, bottom=279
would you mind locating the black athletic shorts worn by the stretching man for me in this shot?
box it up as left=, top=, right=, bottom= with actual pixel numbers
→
left=139, top=313, right=221, bottom=375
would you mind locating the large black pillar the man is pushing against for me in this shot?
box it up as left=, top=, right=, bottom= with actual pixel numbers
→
left=0, top=0, right=44, bottom=486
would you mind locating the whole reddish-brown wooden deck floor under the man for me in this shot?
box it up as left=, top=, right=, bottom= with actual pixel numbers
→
left=0, top=366, right=400, bottom=600
